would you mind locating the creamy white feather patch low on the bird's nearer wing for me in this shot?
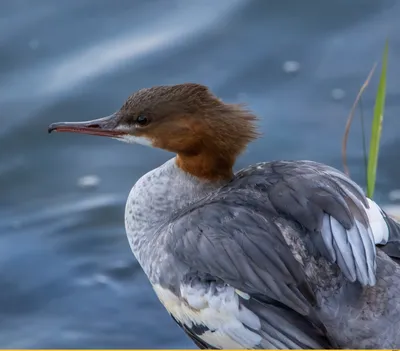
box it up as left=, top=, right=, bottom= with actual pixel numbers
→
left=153, top=284, right=262, bottom=349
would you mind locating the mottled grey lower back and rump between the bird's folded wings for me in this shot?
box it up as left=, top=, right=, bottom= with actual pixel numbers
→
left=284, top=212, right=400, bottom=349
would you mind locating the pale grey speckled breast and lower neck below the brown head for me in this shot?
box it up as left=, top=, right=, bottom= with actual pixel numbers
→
left=125, top=158, right=224, bottom=274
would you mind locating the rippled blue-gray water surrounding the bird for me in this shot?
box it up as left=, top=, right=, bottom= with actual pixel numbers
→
left=0, top=0, right=400, bottom=348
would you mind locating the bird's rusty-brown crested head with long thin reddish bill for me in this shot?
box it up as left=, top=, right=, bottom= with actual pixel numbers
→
left=49, top=83, right=258, bottom=180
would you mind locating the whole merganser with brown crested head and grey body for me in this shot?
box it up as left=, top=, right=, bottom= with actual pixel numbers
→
left=49, top=83, right=400, bottom=349
